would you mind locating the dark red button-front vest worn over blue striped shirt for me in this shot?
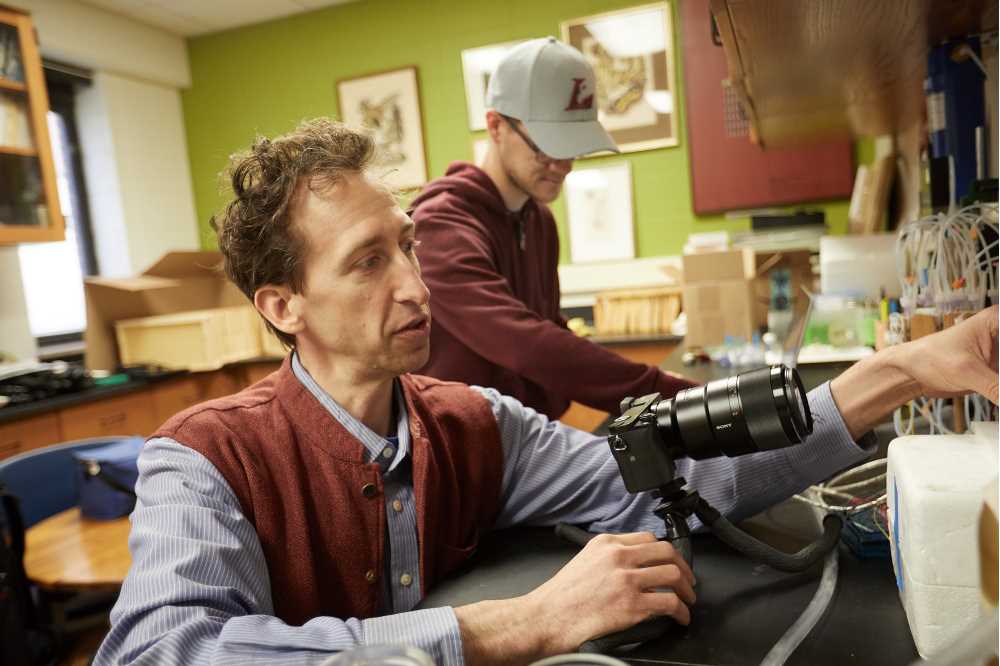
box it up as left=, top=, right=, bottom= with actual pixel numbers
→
left=153, top=359, right=503, bottom=625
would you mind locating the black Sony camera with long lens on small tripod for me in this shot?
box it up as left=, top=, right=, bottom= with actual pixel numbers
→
left=608, top=365, right=813, bottom=493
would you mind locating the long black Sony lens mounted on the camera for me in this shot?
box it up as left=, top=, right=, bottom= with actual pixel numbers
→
left=654, top=365, right=812, bottom=459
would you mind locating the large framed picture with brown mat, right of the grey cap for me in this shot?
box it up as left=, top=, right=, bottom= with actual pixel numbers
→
left=562, top=2, right=678, bottom=153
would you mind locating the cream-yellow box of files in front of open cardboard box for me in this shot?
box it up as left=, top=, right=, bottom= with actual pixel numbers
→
left=115, top=305, right=261, bottom=371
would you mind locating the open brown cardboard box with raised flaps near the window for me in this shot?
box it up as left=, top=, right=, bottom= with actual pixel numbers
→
left=84, top=252, right=248, bottom=370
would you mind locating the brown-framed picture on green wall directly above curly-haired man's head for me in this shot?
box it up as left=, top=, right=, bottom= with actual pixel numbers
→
left=337, top=67, right=427, bottom=189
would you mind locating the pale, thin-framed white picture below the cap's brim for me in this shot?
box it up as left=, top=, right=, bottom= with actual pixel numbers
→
left=565, top=162, right=635, bottom=264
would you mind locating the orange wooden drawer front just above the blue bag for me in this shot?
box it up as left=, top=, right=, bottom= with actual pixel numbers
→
left=59, top=391, right=160, bottom=441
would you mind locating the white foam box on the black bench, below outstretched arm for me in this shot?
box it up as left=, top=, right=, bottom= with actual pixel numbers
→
left=886, top=423, right=998, bottom=658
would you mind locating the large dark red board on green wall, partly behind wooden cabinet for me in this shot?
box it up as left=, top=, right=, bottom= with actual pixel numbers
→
left=678, top=0, right=854, bottom=214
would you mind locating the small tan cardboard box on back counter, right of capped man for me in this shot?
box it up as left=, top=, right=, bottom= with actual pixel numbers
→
left=684, top=280, right=757, bottom=347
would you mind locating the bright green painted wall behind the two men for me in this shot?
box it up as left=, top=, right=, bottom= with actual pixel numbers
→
left=183, top=0, right=869, bottom=261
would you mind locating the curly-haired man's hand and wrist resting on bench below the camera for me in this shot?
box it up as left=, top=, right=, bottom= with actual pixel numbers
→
left=455, top=532, right=695, bottom=664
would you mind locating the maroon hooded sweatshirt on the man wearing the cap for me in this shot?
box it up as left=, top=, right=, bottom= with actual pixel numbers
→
left=410, top=162, right=691, bottom=419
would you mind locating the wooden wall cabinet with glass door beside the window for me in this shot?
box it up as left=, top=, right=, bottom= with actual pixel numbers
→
left=0, top=8, right=65, bottom=245
